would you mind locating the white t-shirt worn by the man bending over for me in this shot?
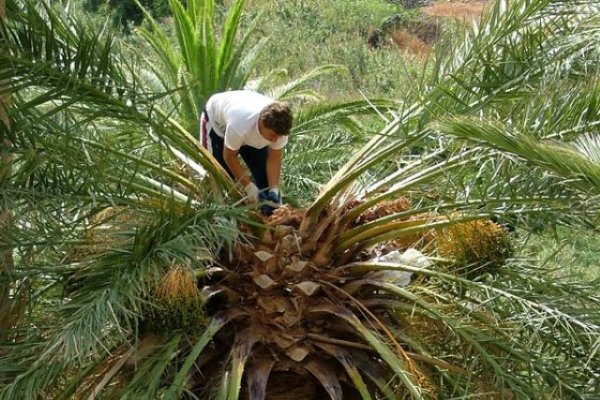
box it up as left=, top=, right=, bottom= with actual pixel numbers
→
left=206, top=90, right=287, bottom=150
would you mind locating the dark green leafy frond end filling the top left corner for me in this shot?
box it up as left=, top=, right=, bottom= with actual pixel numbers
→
left=1, top=3, right=149, bottom=119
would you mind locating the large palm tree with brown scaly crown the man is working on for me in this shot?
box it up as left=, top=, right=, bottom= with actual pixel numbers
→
left=0, top=0, right=600, bottom=399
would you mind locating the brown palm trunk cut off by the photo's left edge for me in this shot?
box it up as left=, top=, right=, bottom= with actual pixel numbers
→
left=0, top=0, right=14, bottom=340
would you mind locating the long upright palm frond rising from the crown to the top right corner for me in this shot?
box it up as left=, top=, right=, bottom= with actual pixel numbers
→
left=308, top=1, right=597, bottom=222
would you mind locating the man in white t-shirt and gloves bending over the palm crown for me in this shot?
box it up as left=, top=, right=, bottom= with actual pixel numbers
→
left=200, top=90, right=292, bottom=215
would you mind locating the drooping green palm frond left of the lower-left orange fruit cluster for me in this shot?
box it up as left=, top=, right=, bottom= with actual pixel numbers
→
left=3, top=199, right=248, bottom=394
